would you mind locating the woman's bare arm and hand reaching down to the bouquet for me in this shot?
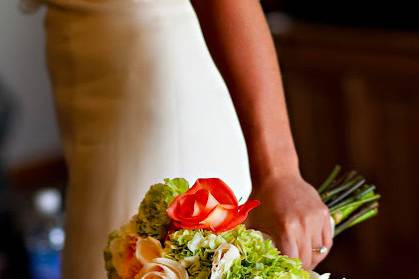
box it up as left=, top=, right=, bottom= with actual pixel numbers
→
left=192, top=0, right=332, bottom=268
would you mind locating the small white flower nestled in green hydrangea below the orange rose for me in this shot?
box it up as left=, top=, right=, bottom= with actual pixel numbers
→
left=210, top=243, right=240, bottom=279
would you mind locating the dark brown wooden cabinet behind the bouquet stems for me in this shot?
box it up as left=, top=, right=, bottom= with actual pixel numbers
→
left=275, top=23, right=419, bottom=279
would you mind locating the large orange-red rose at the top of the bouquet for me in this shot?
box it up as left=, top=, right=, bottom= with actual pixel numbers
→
left=167, top=178, right=260, bottom=233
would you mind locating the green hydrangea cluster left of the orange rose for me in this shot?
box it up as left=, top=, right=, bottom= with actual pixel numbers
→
left=135, top=178, right=189, bottom=240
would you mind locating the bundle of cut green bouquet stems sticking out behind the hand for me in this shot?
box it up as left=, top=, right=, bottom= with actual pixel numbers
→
left=318, top=166, right=380, bottom=236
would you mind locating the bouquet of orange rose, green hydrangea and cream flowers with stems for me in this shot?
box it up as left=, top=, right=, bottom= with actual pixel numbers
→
left=104, top=167, right=379, bottom=279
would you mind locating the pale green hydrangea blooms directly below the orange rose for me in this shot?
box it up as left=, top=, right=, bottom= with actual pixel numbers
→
left=164, top=225, right=309, bottom=279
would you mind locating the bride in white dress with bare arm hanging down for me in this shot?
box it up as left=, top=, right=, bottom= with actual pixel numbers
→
left=27, top=0, right=332, bottom=279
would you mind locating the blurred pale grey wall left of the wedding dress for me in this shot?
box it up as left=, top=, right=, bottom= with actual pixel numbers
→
left=0, top=0, right=60, bottom=167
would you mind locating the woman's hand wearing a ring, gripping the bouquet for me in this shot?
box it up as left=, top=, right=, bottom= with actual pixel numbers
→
left=248, top=176, right=332, bottom=270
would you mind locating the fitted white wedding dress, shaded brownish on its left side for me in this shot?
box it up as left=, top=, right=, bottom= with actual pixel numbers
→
left=41, top=0, right=251, bottom=279
